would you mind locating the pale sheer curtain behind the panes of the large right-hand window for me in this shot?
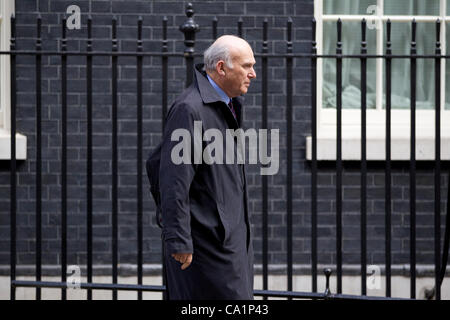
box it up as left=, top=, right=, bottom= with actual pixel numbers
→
left=322, top=0, right=450, bottom=109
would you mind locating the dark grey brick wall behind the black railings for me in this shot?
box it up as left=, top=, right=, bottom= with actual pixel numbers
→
left=0, top=0, right=448, bottom=276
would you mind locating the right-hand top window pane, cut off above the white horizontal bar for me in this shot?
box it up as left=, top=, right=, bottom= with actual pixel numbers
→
left=384, top=0, right=440, bottom=16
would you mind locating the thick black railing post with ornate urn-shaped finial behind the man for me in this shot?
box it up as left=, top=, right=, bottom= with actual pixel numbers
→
left=180, top=2, right=200, bottom=87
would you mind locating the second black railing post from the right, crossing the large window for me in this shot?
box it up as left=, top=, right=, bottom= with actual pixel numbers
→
left=409, top=19, right=417, bottom=298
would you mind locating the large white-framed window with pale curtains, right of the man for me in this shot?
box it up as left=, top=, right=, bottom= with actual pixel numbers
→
left=307, top=0, right=450, bottom=160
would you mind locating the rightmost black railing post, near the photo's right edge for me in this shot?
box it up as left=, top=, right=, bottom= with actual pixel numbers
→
left=434, top=19, right=442, bottom=300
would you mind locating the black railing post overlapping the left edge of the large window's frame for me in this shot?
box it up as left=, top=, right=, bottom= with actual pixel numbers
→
left=311, top=19, right=317, bottom=292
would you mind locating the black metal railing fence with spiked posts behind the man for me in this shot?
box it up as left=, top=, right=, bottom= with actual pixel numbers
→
left=7, top=5, right=450, bottom=299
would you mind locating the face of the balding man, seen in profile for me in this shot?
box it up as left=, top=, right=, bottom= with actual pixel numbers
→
left=224, top=47, right=256, bottom=97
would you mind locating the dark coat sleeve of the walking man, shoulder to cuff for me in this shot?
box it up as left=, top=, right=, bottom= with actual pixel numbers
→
left=159, top=103, right=196, bottom=255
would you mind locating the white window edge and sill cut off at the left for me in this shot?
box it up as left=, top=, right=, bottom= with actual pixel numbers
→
left=0, top=0, right=27, bottom=160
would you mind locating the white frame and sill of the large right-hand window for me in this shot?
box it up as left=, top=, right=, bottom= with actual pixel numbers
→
left=306, top=0, right=450, bottom=160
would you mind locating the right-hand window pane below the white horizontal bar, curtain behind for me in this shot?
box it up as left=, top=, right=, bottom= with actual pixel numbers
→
left=383, top=23, right=435, bottom=109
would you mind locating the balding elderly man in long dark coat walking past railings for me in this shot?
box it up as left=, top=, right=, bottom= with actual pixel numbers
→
left=147, top=35, right=256, bottom=300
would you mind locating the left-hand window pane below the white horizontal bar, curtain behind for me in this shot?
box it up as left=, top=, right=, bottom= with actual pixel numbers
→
left=322, top=21, right=376, bottom=109
